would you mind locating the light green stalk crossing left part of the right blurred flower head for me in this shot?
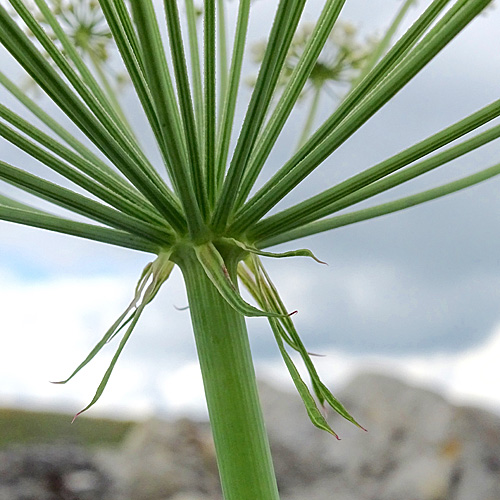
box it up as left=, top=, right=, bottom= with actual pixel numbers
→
left=236, top=0, right=346, bottom=208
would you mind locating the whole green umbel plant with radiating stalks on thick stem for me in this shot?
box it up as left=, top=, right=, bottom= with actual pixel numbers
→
left=0, top=0, right=500, bottom=500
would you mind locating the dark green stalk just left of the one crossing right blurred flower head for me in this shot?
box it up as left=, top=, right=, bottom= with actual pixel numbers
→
left=212, top=0, right=305, bottom=231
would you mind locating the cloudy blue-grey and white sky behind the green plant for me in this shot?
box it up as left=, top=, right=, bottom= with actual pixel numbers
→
left=0, top=0, right=500, bottom=422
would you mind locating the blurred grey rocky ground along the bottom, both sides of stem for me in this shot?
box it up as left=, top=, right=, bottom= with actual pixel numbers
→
left=0, top=374, right=500, bottom=500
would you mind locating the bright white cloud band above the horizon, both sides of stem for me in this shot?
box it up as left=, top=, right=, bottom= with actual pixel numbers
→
left=0, top=270, right=500, bottom=417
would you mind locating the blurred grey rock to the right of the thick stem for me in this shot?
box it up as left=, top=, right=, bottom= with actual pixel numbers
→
left=261, top=373, right=500, bottom=500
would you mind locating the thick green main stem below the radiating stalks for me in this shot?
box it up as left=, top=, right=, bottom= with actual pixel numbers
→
left=176, top=252, right=279, bottom=500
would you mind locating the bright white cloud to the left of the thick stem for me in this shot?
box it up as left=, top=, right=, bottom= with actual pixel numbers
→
left=0, top=268, right=199, bottom=417
